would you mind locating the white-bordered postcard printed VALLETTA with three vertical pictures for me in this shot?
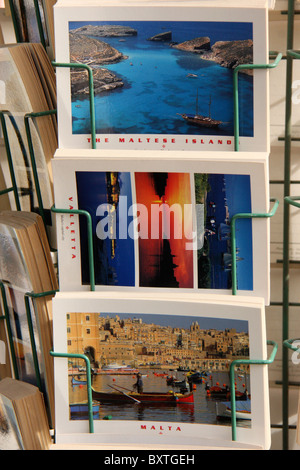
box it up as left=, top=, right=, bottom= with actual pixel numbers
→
left=53, top=150, right=268, bottom=301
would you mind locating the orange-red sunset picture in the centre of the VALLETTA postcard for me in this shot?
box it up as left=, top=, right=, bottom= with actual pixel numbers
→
left=135, top=173, right=193, bottom=288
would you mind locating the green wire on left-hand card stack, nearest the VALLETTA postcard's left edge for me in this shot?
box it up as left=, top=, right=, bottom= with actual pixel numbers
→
left=24, top=109, right=57, bottom=226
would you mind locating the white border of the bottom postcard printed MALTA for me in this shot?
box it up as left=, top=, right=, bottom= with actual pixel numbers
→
left=53, top=292, right=270, bottom=448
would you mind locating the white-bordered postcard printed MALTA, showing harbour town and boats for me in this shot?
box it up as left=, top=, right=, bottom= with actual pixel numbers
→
left=53, top=292, right=268, bottom=445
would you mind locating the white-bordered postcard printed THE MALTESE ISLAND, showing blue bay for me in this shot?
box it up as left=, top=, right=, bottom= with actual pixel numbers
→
left=54, top=1, right=269, bottom=152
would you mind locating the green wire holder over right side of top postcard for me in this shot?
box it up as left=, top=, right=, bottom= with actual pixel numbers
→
left=233, top=53, right=282, bottom=151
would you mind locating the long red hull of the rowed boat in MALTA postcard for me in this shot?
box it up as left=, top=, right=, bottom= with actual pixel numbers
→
left=92, top=387, right=194, bottom=405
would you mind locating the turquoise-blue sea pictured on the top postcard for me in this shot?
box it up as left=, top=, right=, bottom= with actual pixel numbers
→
left=69, top=21, right=253, bottom=137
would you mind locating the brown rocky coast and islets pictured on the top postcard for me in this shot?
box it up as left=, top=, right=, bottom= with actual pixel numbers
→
left=69, top=25, right=253, bottom=95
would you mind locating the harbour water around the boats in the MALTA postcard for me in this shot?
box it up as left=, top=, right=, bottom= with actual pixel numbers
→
left=69, top=369, right=251, bottom=427
